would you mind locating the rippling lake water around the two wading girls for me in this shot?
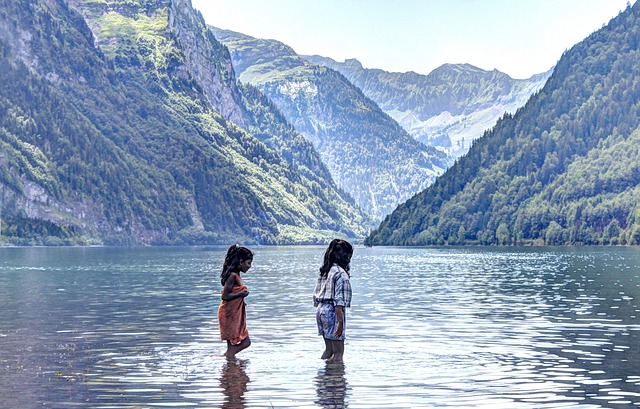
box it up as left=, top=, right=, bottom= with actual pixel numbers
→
left=0, top=246, right=640, bottom=409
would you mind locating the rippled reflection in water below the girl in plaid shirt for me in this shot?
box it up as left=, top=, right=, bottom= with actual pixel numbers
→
left=315, top=361, right=349, bottom=409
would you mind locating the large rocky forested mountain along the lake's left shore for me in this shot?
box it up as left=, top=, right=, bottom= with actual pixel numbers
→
left=0, top=0, right=369, bottom=244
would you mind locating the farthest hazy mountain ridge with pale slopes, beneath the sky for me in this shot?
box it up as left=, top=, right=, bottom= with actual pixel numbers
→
left=303, top=55, right=553, bottom=157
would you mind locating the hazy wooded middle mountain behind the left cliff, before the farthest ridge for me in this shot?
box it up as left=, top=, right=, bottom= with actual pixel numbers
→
left=209, top=27, right=451, bottom=221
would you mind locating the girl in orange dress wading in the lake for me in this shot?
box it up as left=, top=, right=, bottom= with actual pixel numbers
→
left=218, top=244, right=253, bottom=358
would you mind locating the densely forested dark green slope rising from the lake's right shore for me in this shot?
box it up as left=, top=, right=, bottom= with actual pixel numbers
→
left=366, top=2, right=640, bottom=245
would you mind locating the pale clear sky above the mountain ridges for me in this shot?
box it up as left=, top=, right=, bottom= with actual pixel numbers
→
left=192, top=0, right=635, bottom=78
